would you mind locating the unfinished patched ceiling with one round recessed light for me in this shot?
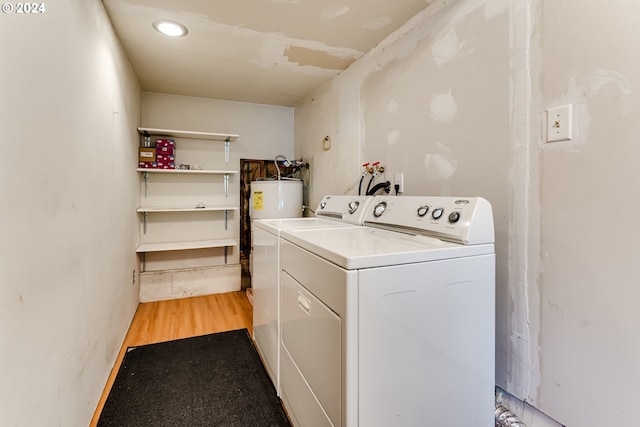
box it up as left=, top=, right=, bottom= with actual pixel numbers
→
left=103, top=0, right=434, bottom=106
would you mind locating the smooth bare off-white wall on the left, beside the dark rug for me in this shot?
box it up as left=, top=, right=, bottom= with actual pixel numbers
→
left=0, top=0, right=140, bottom=426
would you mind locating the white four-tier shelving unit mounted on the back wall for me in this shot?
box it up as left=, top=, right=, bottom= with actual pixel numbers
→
left=136, top=127, right=240, bottom=302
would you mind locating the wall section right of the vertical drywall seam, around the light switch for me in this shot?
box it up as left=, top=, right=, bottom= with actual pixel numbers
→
left=536, top=0, right=640, bottom=427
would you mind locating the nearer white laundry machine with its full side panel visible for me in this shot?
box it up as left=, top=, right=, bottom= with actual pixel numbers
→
left=280, top=196, right=495, bottom=427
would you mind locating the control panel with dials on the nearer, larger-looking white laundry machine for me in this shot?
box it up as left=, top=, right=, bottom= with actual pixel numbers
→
left=364, top=196, right=494, bottom=244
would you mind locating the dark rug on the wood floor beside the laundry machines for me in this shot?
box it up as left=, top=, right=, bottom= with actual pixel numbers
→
left=98, top=329, right=290, bottom=427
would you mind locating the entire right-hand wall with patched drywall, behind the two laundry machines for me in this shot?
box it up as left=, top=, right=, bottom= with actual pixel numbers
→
left=295, top=0, right=640, bottom=427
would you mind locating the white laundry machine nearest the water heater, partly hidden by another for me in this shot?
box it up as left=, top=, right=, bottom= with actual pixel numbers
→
left=251, top=195, right=373, bottom=394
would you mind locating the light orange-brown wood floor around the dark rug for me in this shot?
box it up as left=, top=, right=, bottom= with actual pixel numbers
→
left=90, top=291, right=253, bottom=427
